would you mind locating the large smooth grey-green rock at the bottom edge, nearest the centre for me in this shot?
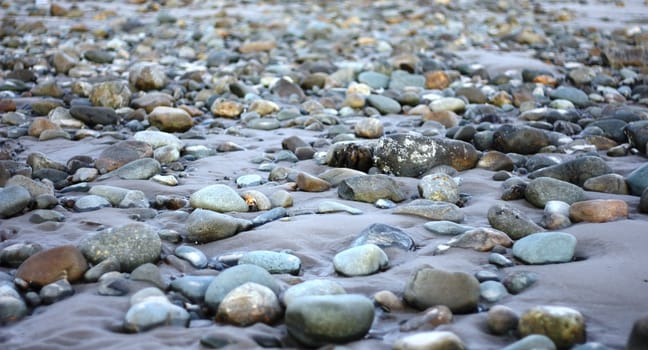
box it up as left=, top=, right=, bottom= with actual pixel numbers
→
left=285, top=294, right=374, bottom=347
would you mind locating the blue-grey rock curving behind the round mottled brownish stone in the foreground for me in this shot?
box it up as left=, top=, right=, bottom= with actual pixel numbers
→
left=205, top=264, right=281, bottom=311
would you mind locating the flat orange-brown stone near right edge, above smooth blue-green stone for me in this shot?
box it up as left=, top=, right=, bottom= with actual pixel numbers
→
left=569, top=199, right=629, bottom=222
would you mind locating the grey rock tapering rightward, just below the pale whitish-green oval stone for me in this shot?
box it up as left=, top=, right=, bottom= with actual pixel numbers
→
left=186, top=207, right=252, bottom=243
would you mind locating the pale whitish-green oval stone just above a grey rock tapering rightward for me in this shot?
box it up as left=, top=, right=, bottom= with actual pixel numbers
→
left=189, top=184, right=248, bottom=212
